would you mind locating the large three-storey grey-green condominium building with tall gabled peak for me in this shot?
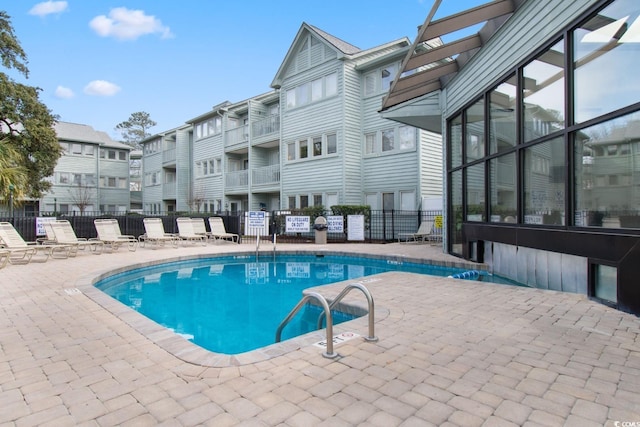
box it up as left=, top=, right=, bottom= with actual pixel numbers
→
left=143, top=23, right=442, bottom=216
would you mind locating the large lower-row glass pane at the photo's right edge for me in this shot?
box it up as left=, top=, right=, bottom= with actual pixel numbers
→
left=574, top=112, right=640, bottom=228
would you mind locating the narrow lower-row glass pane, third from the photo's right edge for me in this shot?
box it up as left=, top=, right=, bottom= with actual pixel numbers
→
left=489, top=153, right=517, bottom=223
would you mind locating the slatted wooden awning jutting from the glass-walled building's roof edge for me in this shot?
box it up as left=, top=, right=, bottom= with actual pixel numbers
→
left=382, top=0, right=525, bottom=111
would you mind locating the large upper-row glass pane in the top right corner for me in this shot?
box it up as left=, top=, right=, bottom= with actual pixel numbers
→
left=573, top=0, right=640, bottom=123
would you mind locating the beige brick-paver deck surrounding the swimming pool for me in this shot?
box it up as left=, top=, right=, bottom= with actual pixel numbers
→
left=0, top=243, right=640, bottom=427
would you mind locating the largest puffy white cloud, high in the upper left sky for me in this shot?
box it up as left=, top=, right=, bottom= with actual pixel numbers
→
left=89, top=7, right=173, bottom=40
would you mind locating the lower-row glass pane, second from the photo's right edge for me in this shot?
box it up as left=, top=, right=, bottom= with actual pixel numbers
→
left=524, top=138, right=565, bottom=225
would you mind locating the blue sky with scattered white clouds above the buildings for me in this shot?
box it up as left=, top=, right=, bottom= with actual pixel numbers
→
left=0, top=0, right=488, bottom=140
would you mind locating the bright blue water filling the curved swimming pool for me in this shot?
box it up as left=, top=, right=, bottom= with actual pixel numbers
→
left=95, top=254, right=524, bottom=354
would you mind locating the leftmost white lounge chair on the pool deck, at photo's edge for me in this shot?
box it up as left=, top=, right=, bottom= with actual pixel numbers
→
left=0, top=222, right=71, bottom=264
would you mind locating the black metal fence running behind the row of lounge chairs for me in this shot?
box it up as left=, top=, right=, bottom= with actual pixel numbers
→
left=0, top=210, right=442, bottom=243
